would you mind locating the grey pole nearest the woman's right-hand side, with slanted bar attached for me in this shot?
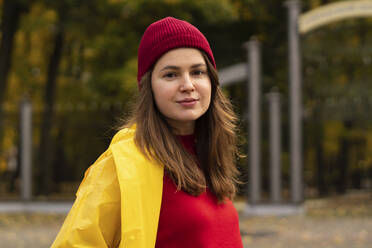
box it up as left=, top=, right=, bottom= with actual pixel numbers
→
left=244, top=37, right=261, bottom=204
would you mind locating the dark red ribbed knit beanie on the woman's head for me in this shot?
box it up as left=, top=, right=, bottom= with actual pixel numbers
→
left=137, top=17, right=216, bottom=86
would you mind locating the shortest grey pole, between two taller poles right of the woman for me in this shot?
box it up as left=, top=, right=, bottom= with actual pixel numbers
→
left=267, top=89, right=282, bottom=202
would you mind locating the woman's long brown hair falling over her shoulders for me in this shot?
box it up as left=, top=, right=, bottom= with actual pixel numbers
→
left=124, top=52, right=239, bottom=202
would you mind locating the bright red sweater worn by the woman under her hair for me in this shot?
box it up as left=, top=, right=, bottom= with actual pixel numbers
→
left=155, top=135, right=243, bottom=248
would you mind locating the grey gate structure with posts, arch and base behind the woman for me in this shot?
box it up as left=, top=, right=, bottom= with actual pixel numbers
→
left=0, top=0, right=372, bottom=215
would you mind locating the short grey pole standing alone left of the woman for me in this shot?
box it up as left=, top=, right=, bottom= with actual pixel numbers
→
left=20, top=98, right=32, bottom=201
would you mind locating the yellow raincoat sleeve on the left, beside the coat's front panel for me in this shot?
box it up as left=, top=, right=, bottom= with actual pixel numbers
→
left=52, top=150, right=121, bottom=248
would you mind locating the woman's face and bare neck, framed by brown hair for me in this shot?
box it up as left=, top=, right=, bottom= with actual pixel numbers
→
left=151, top=48, right=211, bottom=134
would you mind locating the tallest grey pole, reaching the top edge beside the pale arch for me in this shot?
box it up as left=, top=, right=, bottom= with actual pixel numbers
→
left=286, top=0, right=303, bottom=203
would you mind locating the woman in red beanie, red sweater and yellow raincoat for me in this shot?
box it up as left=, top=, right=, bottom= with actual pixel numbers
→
left=52, top=17, right=242, bottom=248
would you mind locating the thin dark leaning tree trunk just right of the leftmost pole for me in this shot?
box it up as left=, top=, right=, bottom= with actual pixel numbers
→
left=39, top=21, right=64, bottom=194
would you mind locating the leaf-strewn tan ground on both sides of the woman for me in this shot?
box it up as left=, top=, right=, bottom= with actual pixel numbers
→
left=0, top=192, right=372, bottom=248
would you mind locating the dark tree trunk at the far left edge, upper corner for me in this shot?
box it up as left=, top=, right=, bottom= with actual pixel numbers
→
left=0, top=0, right=25, bottom=153
